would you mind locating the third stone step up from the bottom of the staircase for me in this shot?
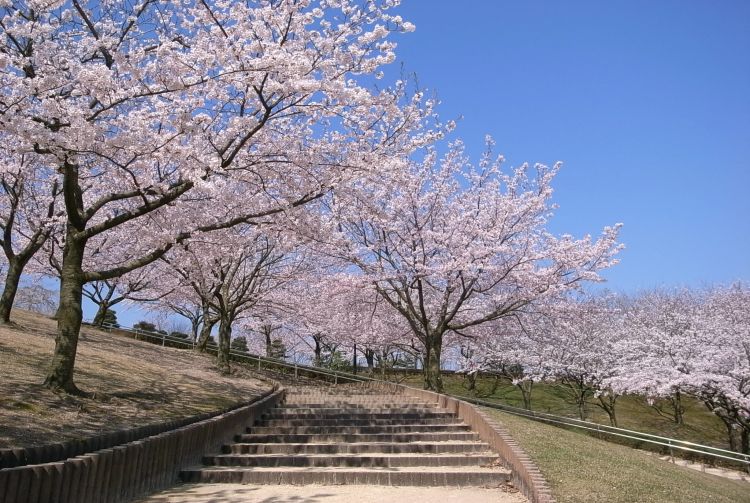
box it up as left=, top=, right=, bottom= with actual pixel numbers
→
left=222, top=441, right=488, bottom=454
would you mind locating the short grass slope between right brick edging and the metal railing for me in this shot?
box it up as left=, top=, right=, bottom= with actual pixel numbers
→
left=485, top=409, right=750, bottom=503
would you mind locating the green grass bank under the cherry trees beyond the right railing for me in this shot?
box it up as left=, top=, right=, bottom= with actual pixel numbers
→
left=404, top=374, right=729, bottom=449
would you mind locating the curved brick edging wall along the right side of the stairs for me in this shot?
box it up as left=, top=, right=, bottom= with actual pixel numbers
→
left=355, top=381, right=555, bottom=503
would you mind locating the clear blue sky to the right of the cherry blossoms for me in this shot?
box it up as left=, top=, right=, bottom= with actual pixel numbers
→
left=388, top=0, right=750, bottom=292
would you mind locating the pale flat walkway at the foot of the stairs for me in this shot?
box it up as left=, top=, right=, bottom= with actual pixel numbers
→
left=140, top=484, right=528, bottom=503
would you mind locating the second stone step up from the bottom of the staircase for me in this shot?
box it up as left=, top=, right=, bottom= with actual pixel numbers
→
left=203, top=452, right=498, bottom=468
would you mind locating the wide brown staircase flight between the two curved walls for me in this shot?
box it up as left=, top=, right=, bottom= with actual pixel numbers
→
left=182, top=385, right=510, bottom=487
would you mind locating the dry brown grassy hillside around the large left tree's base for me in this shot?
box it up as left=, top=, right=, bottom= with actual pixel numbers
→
left=0, top=310, right=270, bottom=448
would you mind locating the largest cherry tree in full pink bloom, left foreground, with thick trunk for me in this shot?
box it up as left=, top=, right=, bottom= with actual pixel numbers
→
left=0, top=0, right=429, bottom=393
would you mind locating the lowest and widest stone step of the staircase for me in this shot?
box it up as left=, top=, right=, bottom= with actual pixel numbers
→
left=180, top=466, right=510, bottom=487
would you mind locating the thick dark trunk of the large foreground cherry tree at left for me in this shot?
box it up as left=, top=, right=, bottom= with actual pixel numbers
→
left=44, top=234, right=86, bottom=394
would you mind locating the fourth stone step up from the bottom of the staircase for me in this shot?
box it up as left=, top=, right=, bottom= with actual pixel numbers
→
left=235, top=431, right=479, bottom=443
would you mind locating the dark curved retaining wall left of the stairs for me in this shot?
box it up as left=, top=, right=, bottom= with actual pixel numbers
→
left=0, top=389, right=285, bottom=503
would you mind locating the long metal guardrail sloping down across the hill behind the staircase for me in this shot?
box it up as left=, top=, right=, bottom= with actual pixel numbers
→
left=98, top=324, right=750, bottom=472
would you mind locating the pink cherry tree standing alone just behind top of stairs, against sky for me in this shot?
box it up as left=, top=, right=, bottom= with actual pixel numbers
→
left=327, top=140, right=620, bottom=391
